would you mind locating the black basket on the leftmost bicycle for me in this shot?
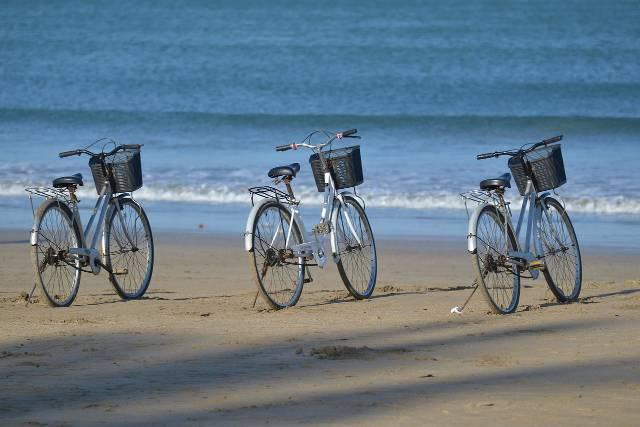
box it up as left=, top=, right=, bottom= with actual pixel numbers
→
left=89, top=149, right=142, bottom=193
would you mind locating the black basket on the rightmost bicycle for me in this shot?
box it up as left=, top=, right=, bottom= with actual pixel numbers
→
left=508, top=145, right=567, bottom=196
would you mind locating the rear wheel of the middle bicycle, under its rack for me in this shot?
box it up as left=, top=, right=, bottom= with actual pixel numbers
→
left=249, top=201, right=305, bottom=310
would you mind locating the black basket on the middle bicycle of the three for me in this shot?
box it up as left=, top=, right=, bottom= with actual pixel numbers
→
left=309, top=145, right=364, bottom=193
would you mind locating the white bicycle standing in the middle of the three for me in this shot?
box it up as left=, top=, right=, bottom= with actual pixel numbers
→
left=245, top=129, right=377, bottom=309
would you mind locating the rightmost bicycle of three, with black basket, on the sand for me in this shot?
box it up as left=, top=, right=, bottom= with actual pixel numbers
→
left=462, top=135, right=582, bottom=314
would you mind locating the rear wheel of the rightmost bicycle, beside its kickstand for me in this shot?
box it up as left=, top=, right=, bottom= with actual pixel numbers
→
left=473, top=205, right=520, bottom=314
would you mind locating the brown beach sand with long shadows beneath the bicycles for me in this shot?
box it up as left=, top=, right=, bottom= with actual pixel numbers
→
left=0, top=231, right=640, bottom=426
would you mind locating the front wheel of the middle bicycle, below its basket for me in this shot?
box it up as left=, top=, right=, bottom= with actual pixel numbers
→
left=334, top=196, right=378, bottom=299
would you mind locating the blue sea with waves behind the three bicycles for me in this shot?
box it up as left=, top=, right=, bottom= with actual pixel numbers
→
left=0, top=0, right=640, bottom=247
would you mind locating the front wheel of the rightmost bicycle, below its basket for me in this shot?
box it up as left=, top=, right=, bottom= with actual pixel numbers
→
left=538, top=197, right=582, bottom=302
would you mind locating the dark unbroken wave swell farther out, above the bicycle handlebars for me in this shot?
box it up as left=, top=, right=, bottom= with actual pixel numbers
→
left=0, top=107, right=640, bottom=133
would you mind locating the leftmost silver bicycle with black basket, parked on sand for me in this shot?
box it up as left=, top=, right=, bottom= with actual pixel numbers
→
left=26, top=140, right=154, bottom=307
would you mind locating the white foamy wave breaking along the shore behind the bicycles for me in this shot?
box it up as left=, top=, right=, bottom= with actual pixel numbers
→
left=5, top=183, right=640, bottom=215
